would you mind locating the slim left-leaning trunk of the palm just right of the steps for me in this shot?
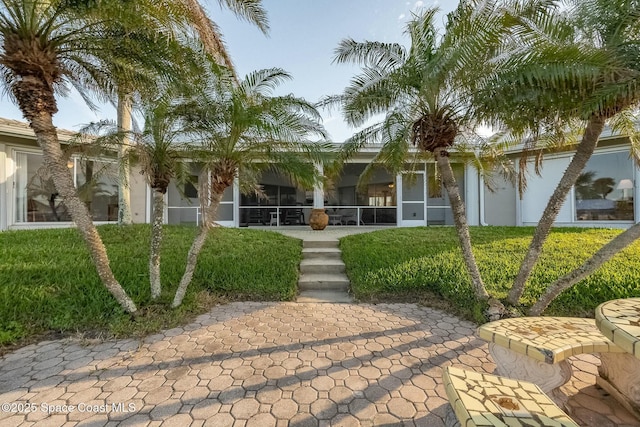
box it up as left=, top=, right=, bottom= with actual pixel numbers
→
left=433, top=149, right=489, bottom=300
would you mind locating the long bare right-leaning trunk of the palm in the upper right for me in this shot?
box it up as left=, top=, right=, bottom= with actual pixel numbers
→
left=507, top=115, right=606, bottom=305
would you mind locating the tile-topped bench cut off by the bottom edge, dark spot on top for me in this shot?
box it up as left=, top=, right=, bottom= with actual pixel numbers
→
left=442, top=366, right=579, bottom=427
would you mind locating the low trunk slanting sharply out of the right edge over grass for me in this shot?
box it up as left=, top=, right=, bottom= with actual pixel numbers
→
left=529, top=223, right=640, bottom=316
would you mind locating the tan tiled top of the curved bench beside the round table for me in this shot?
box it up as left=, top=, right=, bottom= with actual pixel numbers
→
left=478, top=317, right=623, bottom=364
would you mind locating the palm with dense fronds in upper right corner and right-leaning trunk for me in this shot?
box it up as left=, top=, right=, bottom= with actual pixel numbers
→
left=473, top=0, right=640, bottom=304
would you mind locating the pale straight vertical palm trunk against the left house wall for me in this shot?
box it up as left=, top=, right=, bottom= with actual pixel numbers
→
left=117, top=93, right=132, bottom=225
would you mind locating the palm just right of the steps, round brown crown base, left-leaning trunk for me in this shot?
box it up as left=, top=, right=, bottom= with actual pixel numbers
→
left=323, top=0, right=504, bottom=300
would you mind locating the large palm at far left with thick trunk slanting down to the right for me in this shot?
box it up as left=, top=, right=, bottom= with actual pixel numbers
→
left=0, top=0, right=198, bottom=313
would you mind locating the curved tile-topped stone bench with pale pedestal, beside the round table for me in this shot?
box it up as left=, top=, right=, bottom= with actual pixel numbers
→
left=478, top=317, right=624, bottom=406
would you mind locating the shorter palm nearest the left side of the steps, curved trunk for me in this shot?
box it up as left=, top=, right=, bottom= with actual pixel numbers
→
left=172, top=68, right=329, bottom=307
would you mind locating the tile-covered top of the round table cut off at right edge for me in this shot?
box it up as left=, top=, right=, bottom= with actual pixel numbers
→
left=596, top=298, right=640, bottom=359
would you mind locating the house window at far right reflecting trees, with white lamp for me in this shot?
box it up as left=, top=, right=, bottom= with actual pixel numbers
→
left=574, top=152, right=635, bottom=221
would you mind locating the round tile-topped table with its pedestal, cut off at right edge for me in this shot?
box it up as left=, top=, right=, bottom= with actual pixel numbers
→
left=596, top=298, right=640, bottom=419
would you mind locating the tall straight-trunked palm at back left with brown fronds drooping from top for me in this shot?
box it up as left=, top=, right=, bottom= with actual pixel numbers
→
left=116, top=0, right=269, bottom=224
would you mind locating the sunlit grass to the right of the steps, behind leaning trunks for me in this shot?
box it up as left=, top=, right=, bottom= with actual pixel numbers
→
left=340, top=227, right=640, bottom=321
